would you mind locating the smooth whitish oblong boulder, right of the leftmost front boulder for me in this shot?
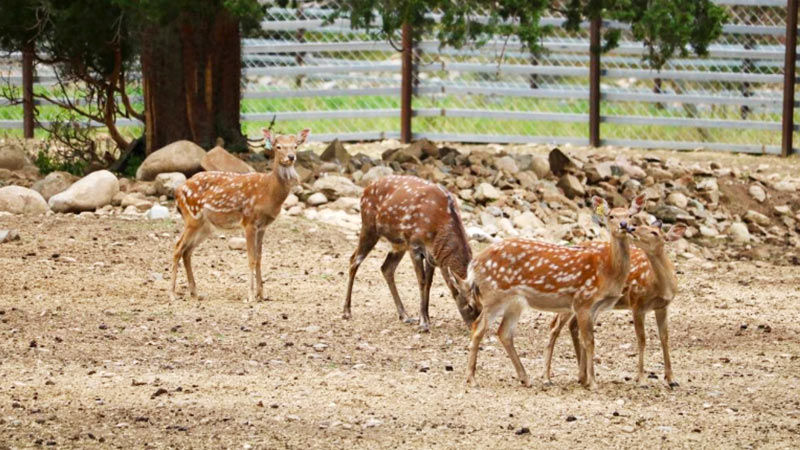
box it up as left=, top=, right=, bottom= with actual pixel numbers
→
left=49, top=170, right=119, bottom=212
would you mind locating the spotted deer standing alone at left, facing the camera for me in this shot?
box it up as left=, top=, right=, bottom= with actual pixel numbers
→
left=170, top=129, right=310, bottom=302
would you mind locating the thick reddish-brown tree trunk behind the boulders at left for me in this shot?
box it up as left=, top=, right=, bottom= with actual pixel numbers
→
left=141, top=8, right=246, bottom=154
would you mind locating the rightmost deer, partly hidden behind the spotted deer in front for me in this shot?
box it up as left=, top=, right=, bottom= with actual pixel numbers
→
left=544, top=220, right=686, bottom=388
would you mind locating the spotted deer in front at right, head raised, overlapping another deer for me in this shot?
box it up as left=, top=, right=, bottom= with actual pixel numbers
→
left=452, top=195, right=645, bottom=389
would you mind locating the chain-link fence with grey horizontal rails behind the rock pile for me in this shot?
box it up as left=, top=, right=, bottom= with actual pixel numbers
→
left=0, top=0, right=796, bottom=153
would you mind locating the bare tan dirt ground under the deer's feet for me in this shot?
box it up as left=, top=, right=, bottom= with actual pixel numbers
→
left=0, top=205, right=800, bottom=449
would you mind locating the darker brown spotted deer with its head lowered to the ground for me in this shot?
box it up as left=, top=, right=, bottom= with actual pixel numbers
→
left=342, top=175, right=477, bottom=332
